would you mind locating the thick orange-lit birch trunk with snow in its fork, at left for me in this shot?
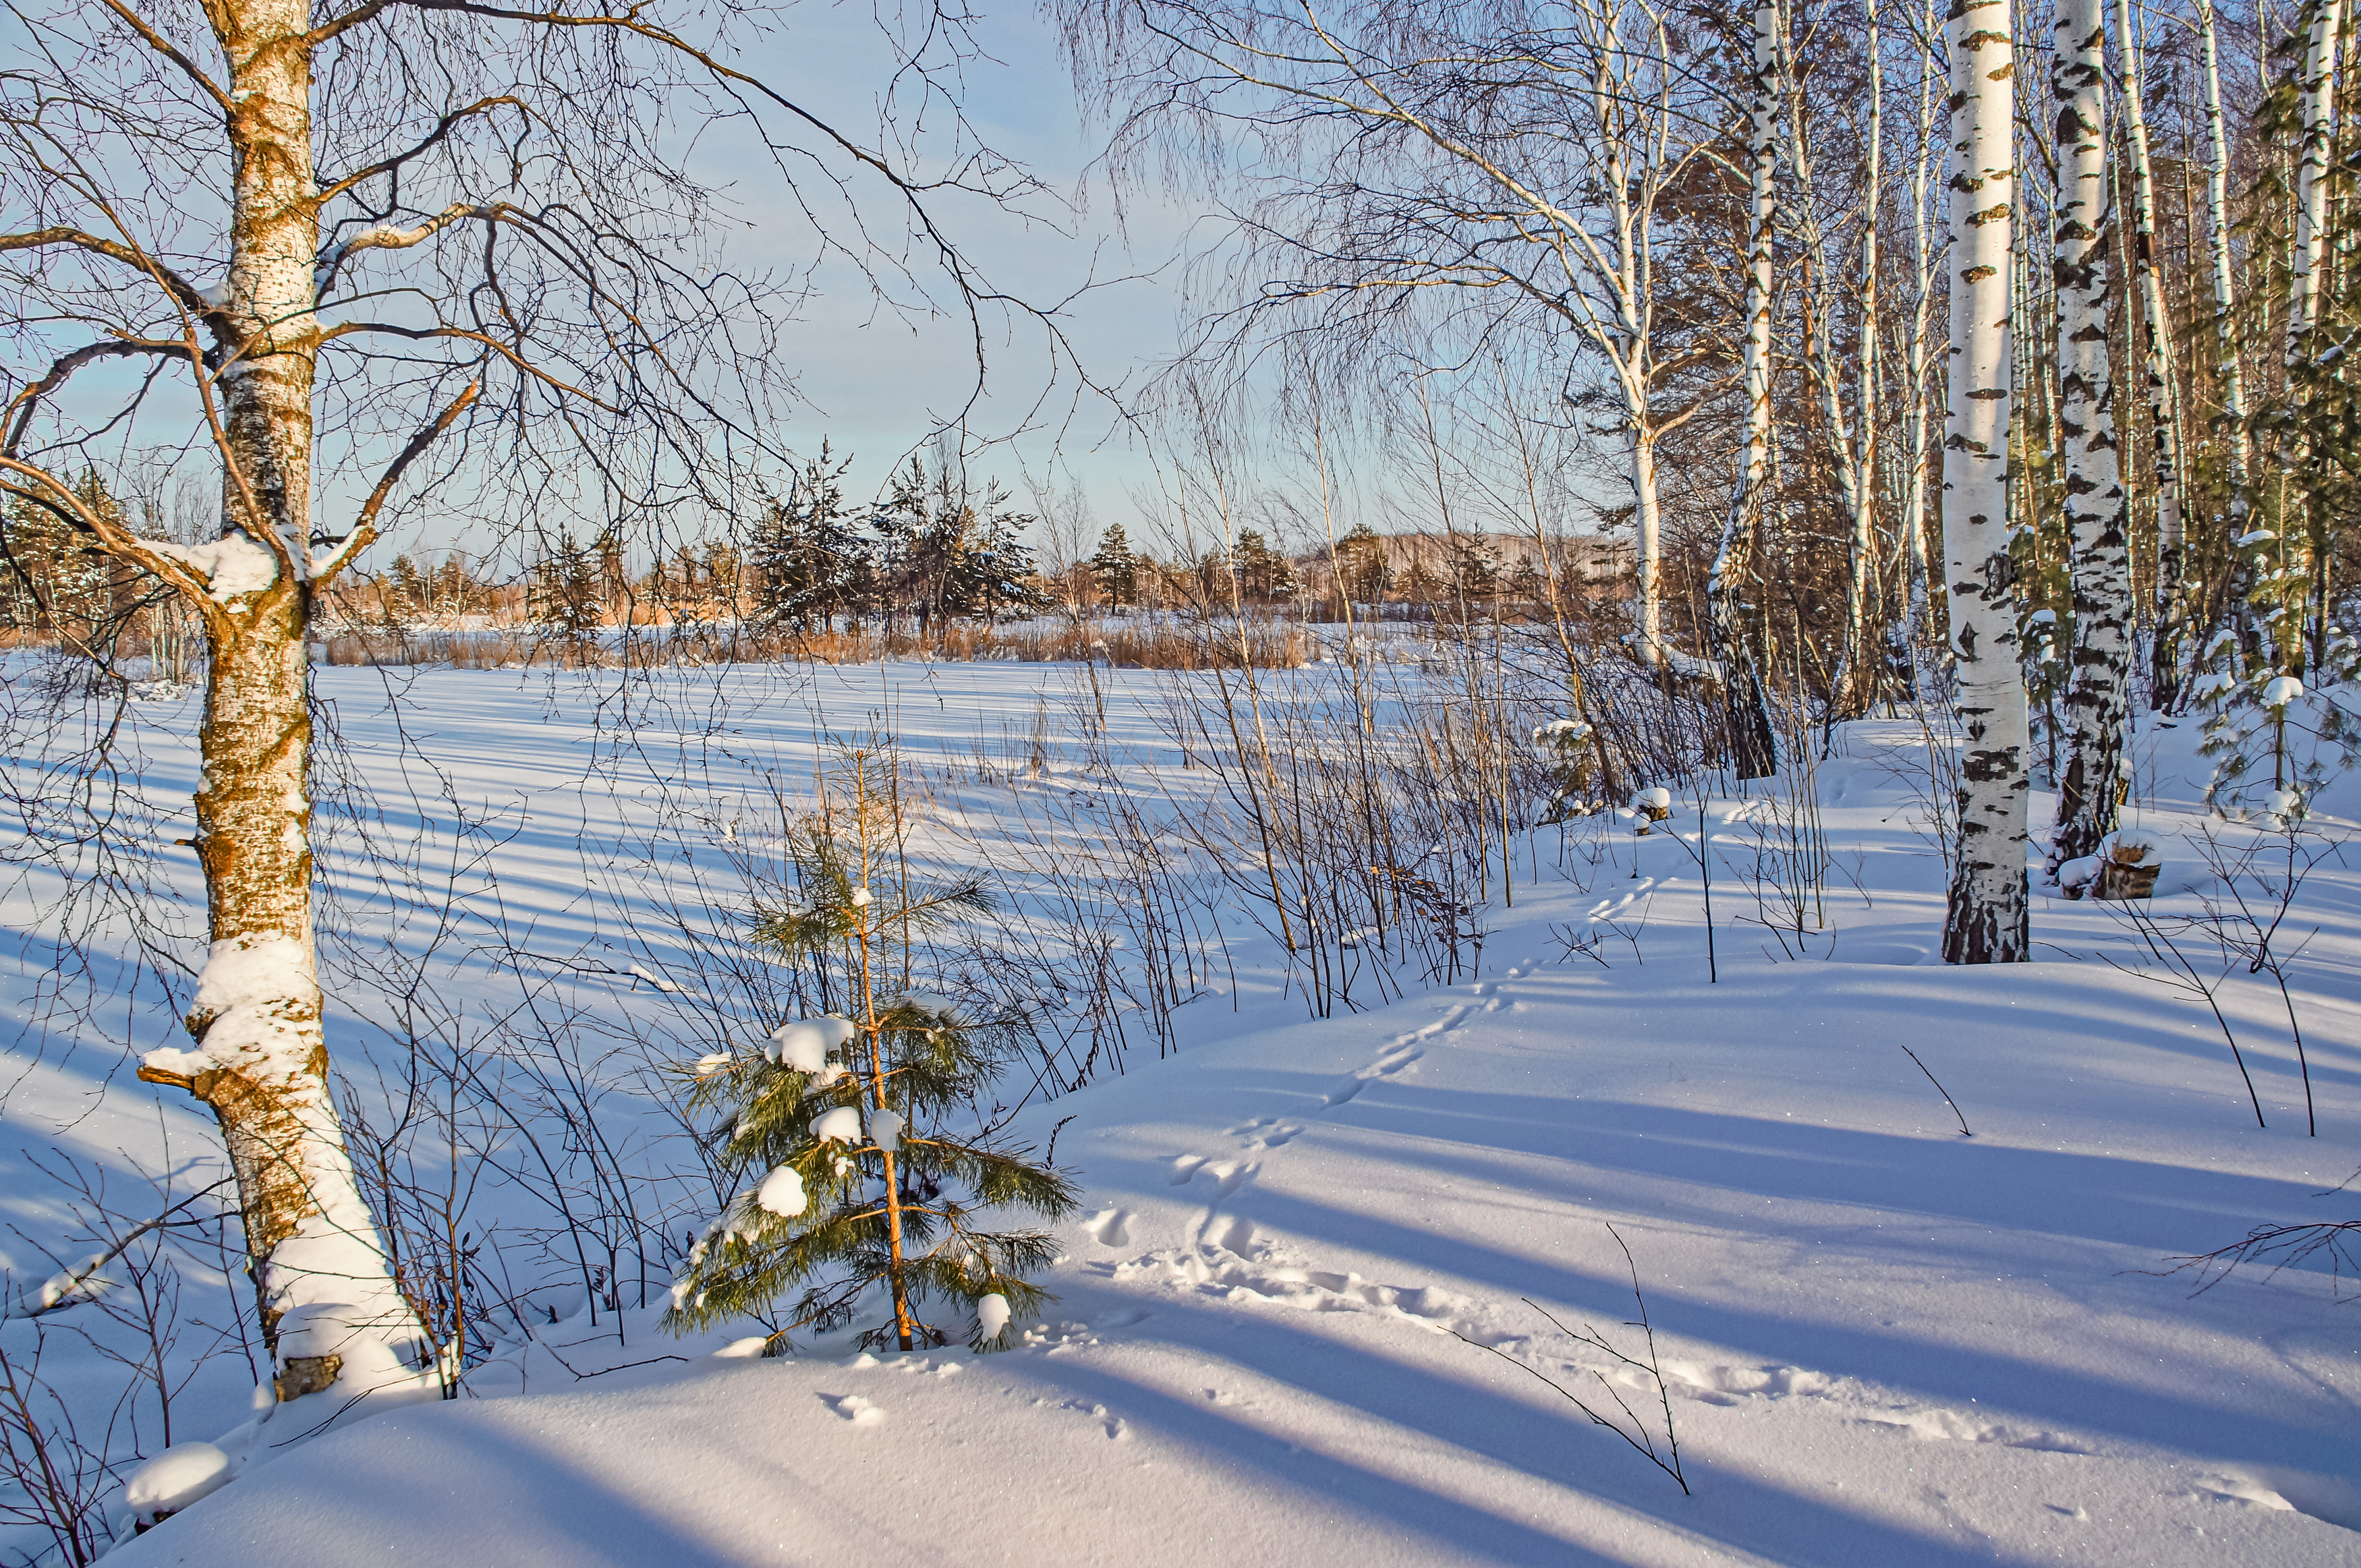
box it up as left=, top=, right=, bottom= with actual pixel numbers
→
left=140, top=0, right=439, bottom=1428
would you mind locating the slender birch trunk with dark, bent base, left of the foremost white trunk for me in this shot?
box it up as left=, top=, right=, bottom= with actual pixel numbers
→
left=1707, top=0, right=1780, bottom=779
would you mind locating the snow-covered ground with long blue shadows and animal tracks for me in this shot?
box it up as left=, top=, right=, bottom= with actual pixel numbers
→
left=0, top=666, right=2361, bottom=1568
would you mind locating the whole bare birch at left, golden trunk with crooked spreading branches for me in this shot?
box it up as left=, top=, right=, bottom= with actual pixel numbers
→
left=0, top=0, right=1053, bottom=1438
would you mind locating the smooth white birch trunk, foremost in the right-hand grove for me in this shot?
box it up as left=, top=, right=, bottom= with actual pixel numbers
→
left=1943, top=0, right=2033, bottom=964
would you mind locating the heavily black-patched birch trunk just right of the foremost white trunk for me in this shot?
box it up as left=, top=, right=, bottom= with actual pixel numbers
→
left=2049, top=0, right=2132, bottom=874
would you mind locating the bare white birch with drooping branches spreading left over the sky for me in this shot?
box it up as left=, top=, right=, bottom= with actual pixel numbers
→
left=1058, top=0, right=1717, bottom=666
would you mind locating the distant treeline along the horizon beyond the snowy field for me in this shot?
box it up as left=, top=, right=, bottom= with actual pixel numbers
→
left=323, top=446, right=1632, bottom=651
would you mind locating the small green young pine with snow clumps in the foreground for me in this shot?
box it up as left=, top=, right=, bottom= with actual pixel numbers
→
left=666, top=751, right=1077, bottom=1351
